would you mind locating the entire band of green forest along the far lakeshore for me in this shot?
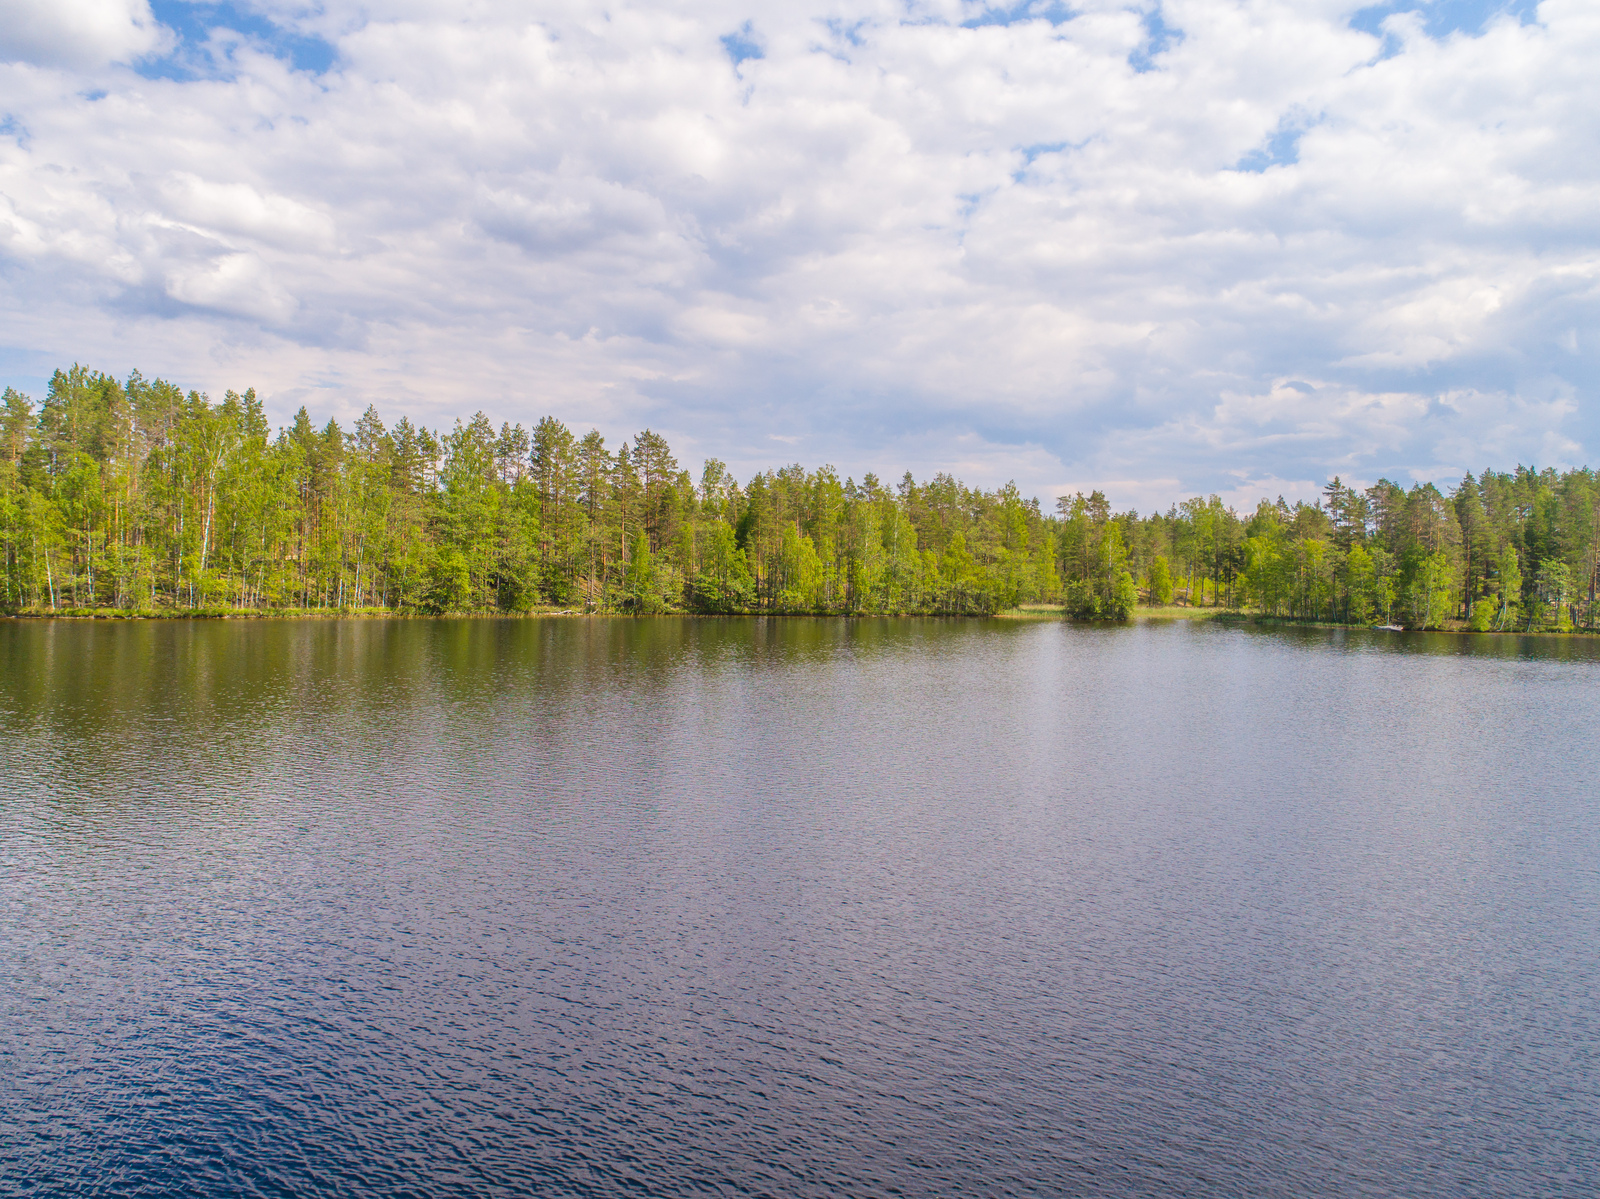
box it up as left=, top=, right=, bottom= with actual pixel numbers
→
left=0, top=367, right=1600, bottom=629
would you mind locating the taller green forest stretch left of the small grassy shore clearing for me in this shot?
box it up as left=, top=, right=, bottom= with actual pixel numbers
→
left=0, top=367, right=1059, bottom=613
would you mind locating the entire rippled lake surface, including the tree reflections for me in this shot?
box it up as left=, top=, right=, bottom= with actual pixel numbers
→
left=0, top=618, right=1600, bottom=1196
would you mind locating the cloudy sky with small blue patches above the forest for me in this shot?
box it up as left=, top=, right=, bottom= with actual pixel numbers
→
left=0, top=0, right=1600, bottom=511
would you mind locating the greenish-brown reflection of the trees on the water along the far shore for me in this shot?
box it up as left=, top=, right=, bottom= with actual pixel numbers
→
left=0, top=616, right=1600, bottom=838
